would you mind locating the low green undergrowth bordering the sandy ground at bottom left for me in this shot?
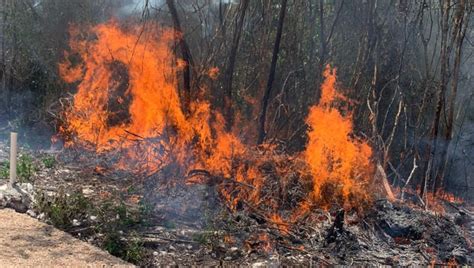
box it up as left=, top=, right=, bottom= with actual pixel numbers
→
left=35, top=191, right=150, bottom=264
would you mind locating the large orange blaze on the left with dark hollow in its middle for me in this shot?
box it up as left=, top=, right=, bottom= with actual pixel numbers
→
left=59, top=21, right=215, bottom=170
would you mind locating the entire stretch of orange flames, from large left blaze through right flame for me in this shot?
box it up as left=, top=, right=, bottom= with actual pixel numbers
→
left=59, top=21, right=373, bottom=233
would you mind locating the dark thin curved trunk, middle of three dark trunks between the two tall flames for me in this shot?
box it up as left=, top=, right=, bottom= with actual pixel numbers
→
left=224, top=0, right=249, bottom=131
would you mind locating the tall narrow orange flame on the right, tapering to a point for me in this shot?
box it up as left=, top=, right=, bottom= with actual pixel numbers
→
left=304, top=66, right=373, bottom=209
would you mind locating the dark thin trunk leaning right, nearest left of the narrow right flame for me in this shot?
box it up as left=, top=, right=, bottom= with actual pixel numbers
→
left=257, top=0, right=288, bottom=144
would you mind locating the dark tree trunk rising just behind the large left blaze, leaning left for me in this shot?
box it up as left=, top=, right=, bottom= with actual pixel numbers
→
left=166, top=0, right=194, bottom=114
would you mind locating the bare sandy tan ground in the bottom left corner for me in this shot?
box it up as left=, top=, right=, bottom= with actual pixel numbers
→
left=0, top=209, right=133, bottom=267
